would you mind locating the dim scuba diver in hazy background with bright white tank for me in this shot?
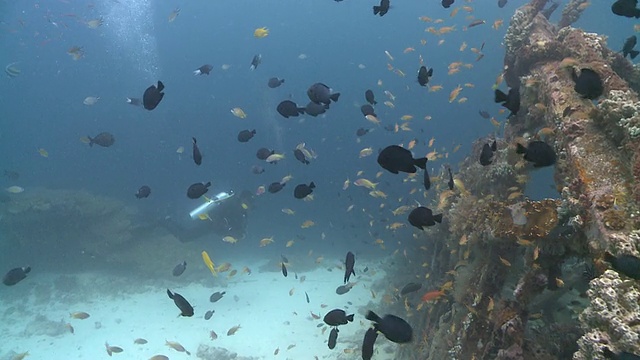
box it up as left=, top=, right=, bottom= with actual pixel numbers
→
left=162, top=190, right=253, bottom=242
